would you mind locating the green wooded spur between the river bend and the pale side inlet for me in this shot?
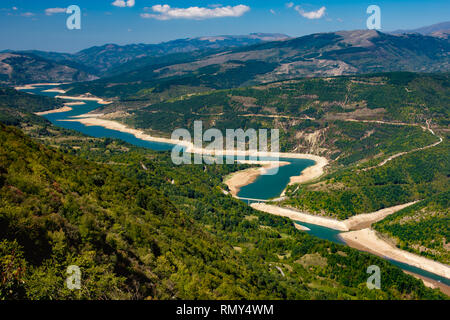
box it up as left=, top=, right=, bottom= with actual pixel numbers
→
left=284, top=142, right=450, bottom=220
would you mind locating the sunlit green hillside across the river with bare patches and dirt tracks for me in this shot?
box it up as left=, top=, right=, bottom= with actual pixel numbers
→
left=90, top=73, right=442, bottom=165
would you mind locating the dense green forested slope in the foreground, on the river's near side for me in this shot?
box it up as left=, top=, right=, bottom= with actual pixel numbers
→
left=0, top=90, right=444, bottom=299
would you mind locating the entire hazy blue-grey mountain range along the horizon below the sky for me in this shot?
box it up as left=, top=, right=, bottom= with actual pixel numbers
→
left=0, top=23, right=450, bottom=91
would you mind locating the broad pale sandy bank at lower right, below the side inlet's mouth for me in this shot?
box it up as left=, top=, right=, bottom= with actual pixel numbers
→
left=340, top=228, right=450, bottom=279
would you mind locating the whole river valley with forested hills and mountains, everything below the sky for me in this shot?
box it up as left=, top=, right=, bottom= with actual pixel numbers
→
left=0, top=21, right=450, bottom=300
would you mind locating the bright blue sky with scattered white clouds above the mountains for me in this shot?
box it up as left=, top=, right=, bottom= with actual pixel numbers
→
left=0, top=0, right=450, bottom=52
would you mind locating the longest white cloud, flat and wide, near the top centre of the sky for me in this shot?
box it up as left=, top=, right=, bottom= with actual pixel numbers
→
left=141, top=4, right=250, bottom=20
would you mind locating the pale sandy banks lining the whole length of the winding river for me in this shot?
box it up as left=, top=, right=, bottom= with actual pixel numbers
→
left=21, top=84, right=450, bottom=296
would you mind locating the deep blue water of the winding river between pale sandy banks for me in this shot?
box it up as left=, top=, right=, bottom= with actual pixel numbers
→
left=23, top=86, right=450, bottom=286
